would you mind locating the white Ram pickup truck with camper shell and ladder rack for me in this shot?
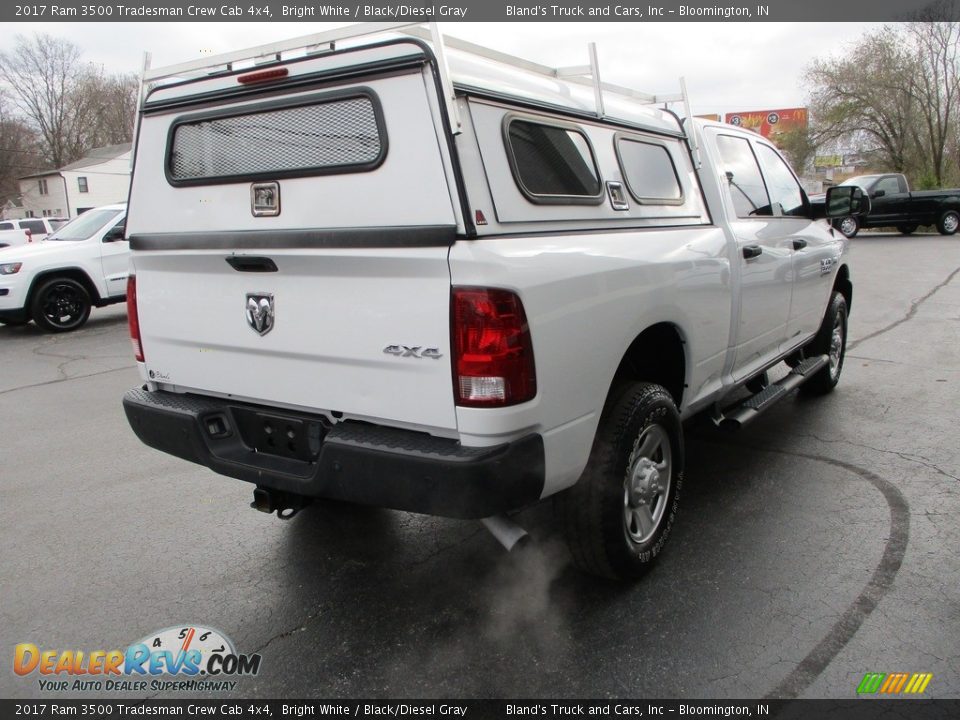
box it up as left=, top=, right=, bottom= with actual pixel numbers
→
left=124, top=26, right=869, bottom=578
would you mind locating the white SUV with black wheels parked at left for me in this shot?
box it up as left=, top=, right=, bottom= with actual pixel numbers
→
left=0, top=204, right=130, bottom=332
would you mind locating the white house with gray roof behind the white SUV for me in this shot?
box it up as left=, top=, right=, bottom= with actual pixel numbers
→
left=20, top=143, right=130, bottom=218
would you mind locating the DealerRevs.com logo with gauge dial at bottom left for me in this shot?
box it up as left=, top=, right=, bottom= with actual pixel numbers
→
left=13, top=624, right=261, bottom=692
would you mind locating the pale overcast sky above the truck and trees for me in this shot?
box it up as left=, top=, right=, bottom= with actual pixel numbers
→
left=0, top=22, right=879, bottom=114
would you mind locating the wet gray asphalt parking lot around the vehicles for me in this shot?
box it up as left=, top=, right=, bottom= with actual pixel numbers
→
left=0, top=234, right=960, bottom=699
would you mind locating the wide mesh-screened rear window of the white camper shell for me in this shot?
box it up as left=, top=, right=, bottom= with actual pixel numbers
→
left=167, top=93, right=386, bottom=185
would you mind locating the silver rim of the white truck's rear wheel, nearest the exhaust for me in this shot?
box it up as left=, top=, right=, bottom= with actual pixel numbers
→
left=623, top=425, right=673, bottom=544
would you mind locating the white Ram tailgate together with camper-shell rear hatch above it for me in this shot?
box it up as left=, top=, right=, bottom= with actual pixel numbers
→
left=127, top=48, right=457, bottom=435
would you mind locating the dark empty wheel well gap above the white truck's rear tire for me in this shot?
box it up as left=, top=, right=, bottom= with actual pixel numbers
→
left=607, top=322, right=687, bottom=408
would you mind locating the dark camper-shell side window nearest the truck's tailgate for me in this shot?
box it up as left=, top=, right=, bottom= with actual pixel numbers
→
left=504, top=116, right=603, bottom=205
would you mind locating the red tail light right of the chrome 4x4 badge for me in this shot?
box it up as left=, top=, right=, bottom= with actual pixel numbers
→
left=451, top=287, right=537, bottom=407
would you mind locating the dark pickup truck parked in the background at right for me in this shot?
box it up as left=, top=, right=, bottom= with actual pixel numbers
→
left=811, top=173, right=960, bottom=238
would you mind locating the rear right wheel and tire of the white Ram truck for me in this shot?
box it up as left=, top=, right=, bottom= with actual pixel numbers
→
left=555, top=383, right=684, bottom=580
